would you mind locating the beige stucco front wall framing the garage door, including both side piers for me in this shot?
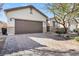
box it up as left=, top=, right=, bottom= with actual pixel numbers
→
left=6, top=8, right=47, bottom=35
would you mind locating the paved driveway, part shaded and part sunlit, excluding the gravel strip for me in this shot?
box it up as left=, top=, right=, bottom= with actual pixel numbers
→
left=1, top=33, right=79, bottom=54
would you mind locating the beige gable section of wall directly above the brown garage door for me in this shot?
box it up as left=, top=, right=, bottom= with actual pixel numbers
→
left=6, top=8, right=46, bottom=21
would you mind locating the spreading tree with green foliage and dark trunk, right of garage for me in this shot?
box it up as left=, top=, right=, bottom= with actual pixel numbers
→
left=47, top=3, right=79, bottom=33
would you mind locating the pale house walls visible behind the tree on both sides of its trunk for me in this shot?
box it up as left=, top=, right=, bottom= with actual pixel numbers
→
left=48, top=18, right=79, bottom=31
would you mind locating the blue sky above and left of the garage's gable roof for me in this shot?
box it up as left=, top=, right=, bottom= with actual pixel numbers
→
left=0, top=3, right=53, bottom=22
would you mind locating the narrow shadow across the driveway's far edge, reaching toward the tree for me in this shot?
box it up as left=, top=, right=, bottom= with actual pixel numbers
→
left=27, top=33, right=70, bottom=41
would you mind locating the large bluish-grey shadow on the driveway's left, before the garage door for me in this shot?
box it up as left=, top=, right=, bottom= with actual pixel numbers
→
left=1, top=35, right=46, bottom=55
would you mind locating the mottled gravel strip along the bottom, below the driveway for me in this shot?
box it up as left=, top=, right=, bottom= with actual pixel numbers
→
left=5, top=49, right=79, bottom=56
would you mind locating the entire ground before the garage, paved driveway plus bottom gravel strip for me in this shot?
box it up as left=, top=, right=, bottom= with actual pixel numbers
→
left=0, top=33, right=79, bottom=56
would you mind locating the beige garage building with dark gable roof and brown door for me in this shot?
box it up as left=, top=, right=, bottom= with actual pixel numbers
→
left=4, top=5, right=48, bottom=35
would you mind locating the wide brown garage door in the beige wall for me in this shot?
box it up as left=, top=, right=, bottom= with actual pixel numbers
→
left=15, top=19, right=43, bottom=34
